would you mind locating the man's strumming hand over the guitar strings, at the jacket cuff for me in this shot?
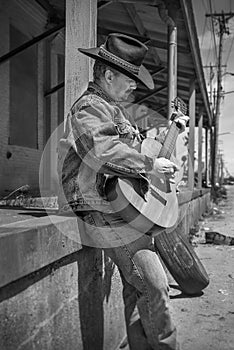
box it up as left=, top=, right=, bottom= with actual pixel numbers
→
left=149, top=157, right=179, bottom=182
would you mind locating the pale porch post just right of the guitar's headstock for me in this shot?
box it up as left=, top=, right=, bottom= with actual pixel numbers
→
left=188, top=81, right=196, bottom=190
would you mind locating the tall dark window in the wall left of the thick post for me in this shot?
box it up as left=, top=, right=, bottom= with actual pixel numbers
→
left=9, top=26, right=38, bottom=148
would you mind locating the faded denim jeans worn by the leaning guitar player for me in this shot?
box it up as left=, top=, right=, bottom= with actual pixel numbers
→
left=78, top=211, right=179, bottom=350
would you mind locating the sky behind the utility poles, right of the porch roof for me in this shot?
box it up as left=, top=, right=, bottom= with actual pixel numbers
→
left=192, top=0, right=234, bottom=176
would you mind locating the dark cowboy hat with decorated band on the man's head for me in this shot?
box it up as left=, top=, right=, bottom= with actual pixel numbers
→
left=78, top=33, right=154, bottom=89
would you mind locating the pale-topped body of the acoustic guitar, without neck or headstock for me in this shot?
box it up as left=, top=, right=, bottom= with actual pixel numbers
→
left=107, top=138, right=178, bottom=232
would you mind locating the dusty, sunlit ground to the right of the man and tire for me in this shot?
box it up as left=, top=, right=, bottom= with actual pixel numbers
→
left=171, top=186, right=234, bottom=350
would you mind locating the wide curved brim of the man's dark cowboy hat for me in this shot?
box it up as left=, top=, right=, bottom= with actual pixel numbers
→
left=78, top=47, right=154, bottom=90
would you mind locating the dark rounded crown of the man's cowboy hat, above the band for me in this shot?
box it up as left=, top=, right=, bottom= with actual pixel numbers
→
left=104, top=33, right=148, bottom=67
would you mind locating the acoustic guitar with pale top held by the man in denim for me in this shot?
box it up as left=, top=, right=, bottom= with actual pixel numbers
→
left=106, top=97, right=187, bottom=232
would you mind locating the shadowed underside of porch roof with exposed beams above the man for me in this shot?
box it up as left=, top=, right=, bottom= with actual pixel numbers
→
left=36, top=0, right=212, bottom=127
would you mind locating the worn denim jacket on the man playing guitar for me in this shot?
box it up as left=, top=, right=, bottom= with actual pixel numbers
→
left=58, top=83, right=153, bottom=213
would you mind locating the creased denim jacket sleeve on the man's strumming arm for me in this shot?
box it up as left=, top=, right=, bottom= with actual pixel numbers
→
left=67, top=96, right=153, bottom=177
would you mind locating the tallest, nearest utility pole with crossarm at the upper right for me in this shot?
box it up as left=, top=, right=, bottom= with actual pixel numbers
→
left=206, top=11, right=234, bottom=197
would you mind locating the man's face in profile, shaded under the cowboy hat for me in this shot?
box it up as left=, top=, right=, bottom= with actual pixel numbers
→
left=109, top=73, right=137, bottom=101
